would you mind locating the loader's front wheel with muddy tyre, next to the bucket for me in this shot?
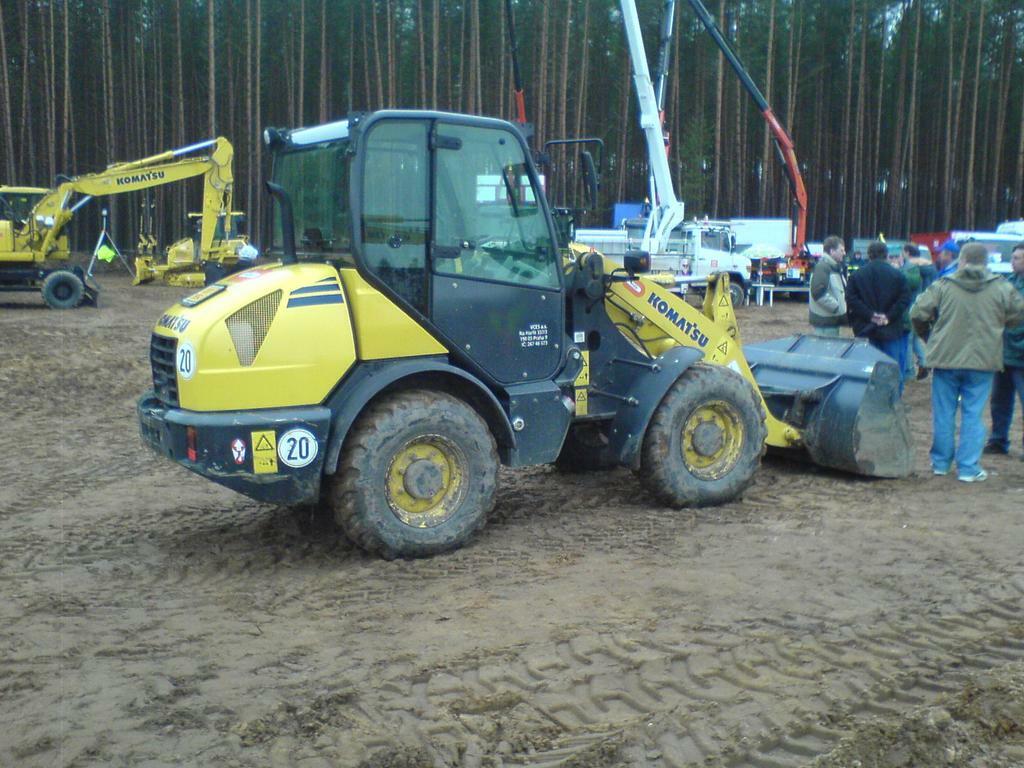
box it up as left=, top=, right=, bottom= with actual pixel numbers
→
left=640, top=362, right=768, bottom=507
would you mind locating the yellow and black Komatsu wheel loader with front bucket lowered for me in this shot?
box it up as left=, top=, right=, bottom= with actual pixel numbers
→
left=137, top=111, right=912, bottom=557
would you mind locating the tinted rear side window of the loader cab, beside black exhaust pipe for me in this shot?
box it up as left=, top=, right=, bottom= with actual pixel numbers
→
left=272, top=139, right=352, bottom=260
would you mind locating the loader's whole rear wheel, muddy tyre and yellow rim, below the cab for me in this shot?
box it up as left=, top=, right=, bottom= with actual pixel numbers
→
left=328, top=390, right=498, bottom=560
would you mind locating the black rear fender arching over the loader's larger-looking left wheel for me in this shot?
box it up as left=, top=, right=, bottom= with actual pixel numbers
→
left=324, top=357, right=516, bottom=474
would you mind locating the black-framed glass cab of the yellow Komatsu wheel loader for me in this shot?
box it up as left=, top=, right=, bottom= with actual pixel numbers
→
left=273, top=111, right=565, bottom=386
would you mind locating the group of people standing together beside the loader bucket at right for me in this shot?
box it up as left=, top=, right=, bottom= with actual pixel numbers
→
left=809, top=237, right=1024, bottom=482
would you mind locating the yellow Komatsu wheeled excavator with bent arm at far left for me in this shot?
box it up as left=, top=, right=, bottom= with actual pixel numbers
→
left=0, top=137, right=246, bottom=309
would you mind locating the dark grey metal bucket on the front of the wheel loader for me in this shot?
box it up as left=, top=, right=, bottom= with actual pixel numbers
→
left=743, top=335, right=913, bottom=477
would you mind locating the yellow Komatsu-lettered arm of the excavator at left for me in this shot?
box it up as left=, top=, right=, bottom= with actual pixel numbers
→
left=30, top=137, right=234, bottom=261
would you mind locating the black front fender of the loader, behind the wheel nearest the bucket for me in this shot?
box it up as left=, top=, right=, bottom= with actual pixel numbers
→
left=608, top=347, right=703, bottom=469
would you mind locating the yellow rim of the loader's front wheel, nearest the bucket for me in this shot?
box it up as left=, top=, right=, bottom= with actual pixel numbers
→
left=682, top=400, right=743, bottom=480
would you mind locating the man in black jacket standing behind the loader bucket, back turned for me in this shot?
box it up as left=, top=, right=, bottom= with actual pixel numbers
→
left=846, top=241, right=910, bottom=393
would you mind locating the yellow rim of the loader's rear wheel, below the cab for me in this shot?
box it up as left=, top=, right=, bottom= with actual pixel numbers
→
left=386, top=435, right=468, bottom=528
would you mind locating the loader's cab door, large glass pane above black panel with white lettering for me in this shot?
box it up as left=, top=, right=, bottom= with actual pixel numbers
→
left=430, top=120, right=564, bottom=385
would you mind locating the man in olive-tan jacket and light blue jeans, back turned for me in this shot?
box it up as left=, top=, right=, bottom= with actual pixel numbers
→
left=910, top=243, right=1024, bottom=482
